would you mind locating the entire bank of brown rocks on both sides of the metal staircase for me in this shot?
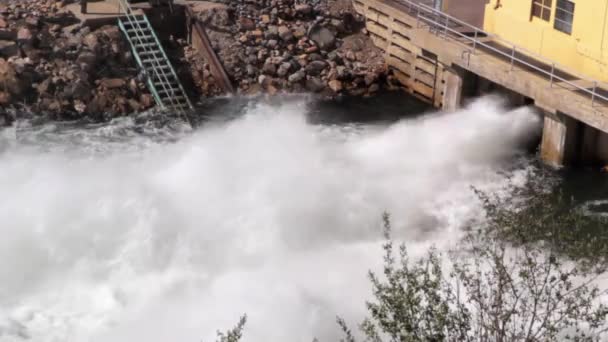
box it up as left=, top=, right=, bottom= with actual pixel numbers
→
left=0, top=0, right=393, bottom=124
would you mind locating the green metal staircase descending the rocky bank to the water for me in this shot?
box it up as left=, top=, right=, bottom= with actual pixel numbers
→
left=118, top=0, right=193, bottom=121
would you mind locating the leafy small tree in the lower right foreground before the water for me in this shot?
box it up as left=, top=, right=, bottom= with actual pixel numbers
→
left=338, top=201, right=608, bottom=342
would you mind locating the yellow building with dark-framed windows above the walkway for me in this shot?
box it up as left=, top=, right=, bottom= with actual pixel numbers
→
left=483, top=0, right=608, bottom=82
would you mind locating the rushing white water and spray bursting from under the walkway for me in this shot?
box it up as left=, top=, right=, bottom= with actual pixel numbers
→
left=0, top=99, right=538, bottom=342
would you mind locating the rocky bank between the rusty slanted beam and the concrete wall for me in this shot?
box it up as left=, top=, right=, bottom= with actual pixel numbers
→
left=189, top=0, right=387, bottom=97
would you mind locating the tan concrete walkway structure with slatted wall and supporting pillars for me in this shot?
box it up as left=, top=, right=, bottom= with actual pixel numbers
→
left=354, top=0, right=608, bottom=166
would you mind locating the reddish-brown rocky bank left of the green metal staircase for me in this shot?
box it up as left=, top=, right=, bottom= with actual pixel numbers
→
left=0, top=0, right=159, bottom=124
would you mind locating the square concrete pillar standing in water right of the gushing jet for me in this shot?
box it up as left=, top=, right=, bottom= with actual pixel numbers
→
left=540, top=113, right=579, bottom=167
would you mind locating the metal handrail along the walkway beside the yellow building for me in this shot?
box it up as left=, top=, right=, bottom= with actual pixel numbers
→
left=395, top=0, right=608, bottom=106
